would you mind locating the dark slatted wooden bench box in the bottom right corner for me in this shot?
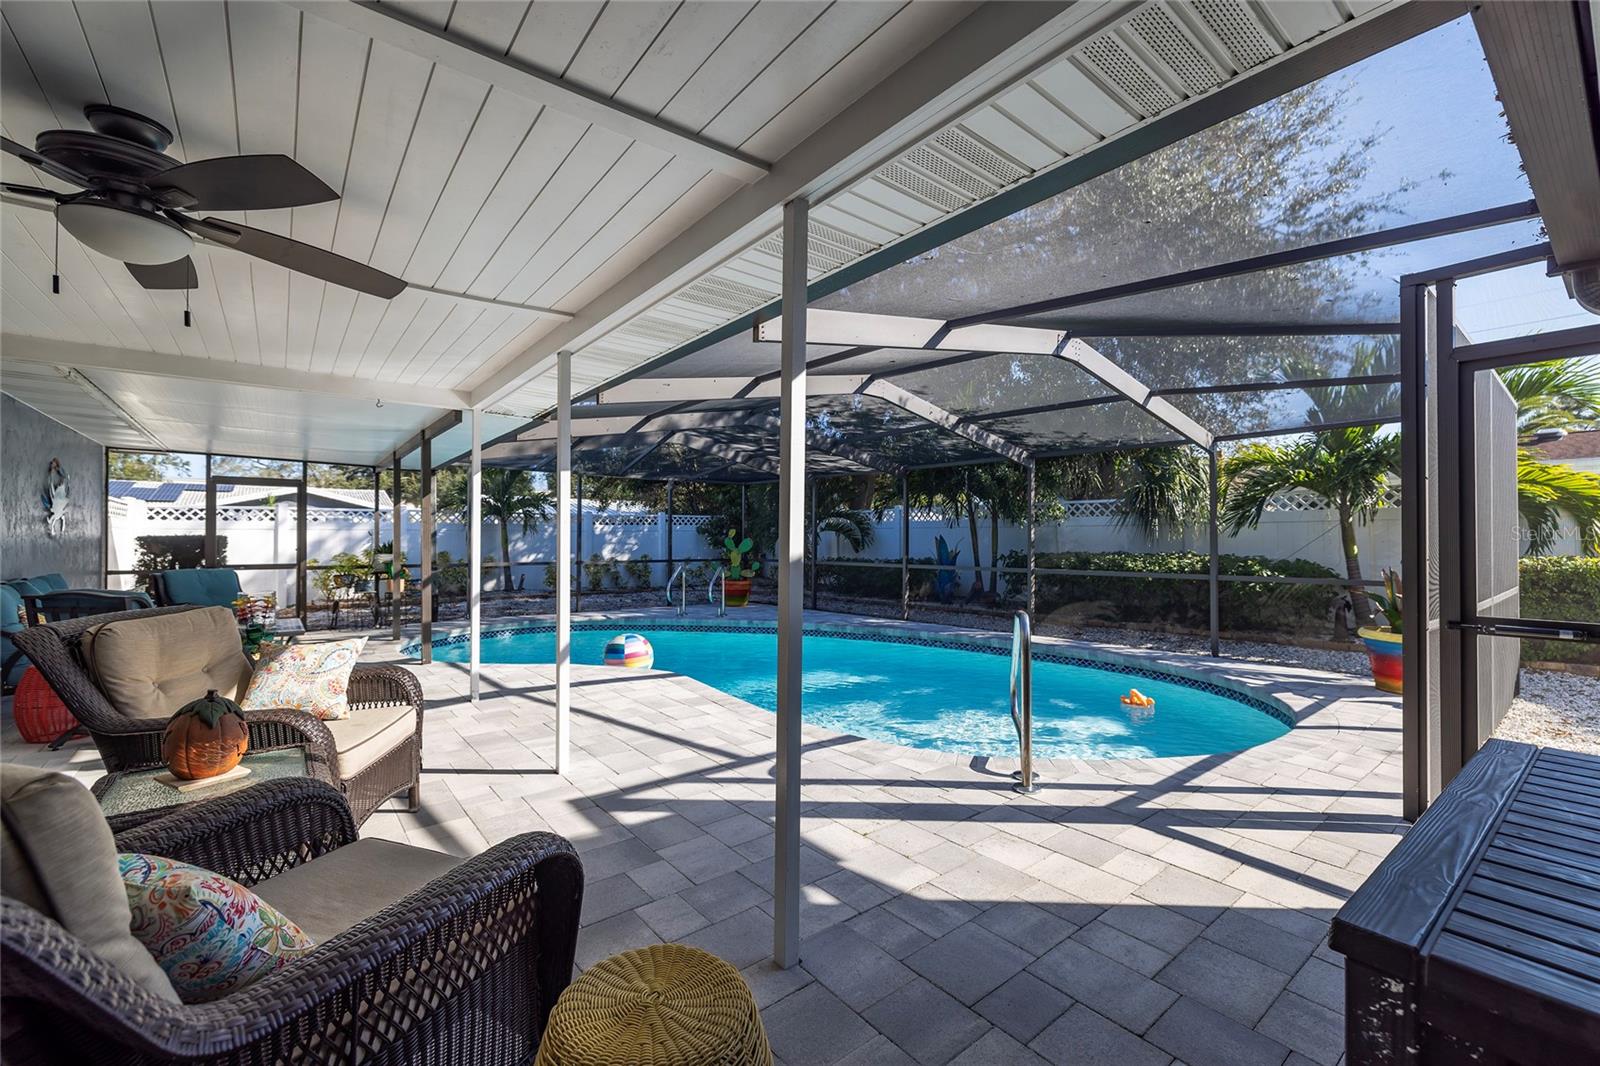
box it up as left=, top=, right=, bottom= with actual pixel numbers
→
left=1330, top=739, right=1600, bottom=1066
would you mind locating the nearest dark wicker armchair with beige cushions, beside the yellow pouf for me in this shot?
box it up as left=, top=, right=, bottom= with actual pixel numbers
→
left=0, top=767, right=584, bottom=1066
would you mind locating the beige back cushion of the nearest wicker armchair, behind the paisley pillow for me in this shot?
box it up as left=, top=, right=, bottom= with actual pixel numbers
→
left=0, top=765, right=178, bottom=1004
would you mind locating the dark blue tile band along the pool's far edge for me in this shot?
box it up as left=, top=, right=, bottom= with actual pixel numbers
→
left=400, top=615, right=1299, bottom=730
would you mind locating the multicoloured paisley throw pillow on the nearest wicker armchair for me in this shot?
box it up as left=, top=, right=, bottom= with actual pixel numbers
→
left=117, top=853, right=315, bottom=1004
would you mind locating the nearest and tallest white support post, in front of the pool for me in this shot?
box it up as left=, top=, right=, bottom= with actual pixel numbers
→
left=773, top=200, right=808, bottom=970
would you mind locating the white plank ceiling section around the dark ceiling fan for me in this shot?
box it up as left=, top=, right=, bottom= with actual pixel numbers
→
left=0, top=0, right=974, bottom=460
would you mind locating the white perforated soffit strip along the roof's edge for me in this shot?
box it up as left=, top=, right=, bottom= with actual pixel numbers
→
left=506, top=0, right=1387, bottom=415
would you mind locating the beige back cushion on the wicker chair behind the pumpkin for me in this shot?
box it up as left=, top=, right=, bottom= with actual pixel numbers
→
left=80, top=607, right=250, bottom=719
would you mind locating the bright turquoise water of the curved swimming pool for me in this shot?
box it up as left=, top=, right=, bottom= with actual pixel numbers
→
left=413, top=619, right=1293, bottom=759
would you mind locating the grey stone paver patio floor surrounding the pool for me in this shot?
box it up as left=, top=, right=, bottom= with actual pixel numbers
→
left=6, top=613, right=1405, bottom=1066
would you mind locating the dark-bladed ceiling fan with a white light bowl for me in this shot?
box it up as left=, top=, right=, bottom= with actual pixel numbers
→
left=0, top=104, right=406, bottom=299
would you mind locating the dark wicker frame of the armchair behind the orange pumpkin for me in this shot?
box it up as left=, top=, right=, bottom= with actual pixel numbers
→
left=10, top=607, right=422, bottom=824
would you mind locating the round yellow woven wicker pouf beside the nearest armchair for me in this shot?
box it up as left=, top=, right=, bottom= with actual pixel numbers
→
left=538, top=944, right=773, bottom=1066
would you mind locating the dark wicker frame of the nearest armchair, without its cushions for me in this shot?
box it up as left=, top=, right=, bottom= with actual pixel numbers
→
left=0, top=779, right=582, bottom=1066
